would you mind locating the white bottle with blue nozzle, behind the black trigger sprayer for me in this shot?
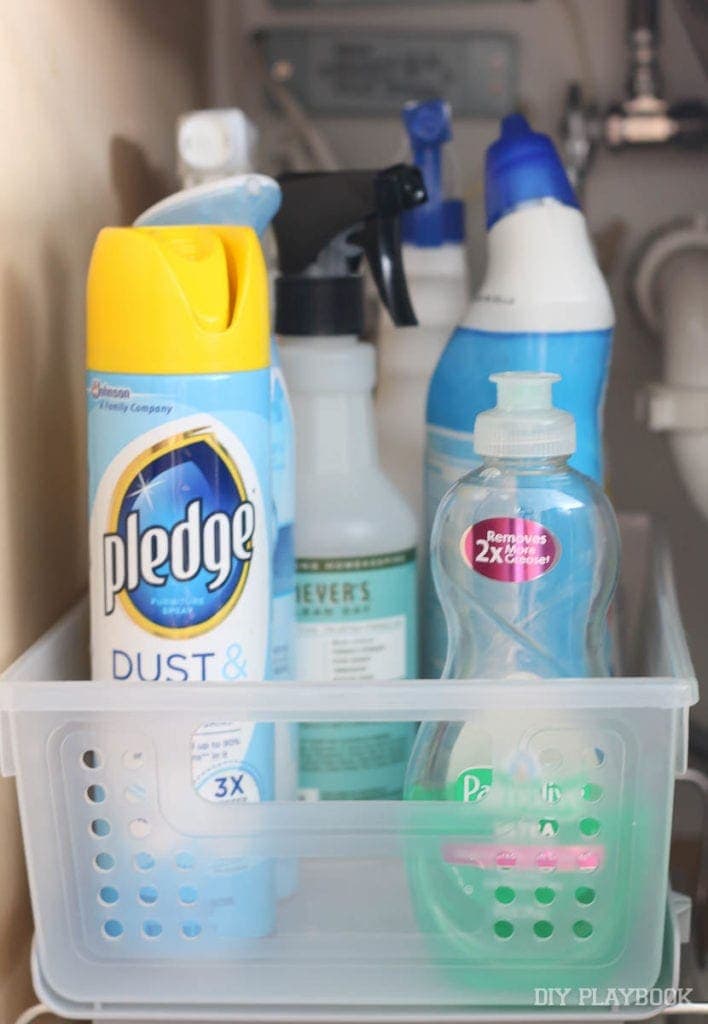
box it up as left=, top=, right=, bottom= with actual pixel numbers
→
left=376, top=99, right=469, bottom=534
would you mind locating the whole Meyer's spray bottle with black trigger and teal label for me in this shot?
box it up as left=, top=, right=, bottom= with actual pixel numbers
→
left=274, top=166, right=425, bottom=800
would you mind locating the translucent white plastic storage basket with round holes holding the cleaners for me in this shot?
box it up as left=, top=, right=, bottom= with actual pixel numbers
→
left=0, top=517, right=697, bottom=1021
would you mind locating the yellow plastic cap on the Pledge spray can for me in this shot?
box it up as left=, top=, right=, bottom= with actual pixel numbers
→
left=86, top=226, right=270, bottom=374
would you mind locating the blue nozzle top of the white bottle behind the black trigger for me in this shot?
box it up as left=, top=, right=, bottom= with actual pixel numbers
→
left=402, top=99, right=464, bottom=248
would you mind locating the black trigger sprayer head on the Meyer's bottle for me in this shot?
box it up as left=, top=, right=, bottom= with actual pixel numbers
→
left=274, top=164, right=427, bottom=337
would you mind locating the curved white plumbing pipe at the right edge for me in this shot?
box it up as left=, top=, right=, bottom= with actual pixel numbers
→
left=632, top=214, right=708, bottom=518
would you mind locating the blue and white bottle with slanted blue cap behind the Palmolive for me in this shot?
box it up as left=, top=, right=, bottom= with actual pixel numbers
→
left=422, top=115, right=615, bottom=679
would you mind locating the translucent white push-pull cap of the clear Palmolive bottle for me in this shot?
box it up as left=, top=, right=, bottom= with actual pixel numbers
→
left=474, top=371, right=576, bottom=459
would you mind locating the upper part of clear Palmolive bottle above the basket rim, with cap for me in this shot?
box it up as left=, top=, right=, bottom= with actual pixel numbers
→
left=423, top=372, right=619, bottom=688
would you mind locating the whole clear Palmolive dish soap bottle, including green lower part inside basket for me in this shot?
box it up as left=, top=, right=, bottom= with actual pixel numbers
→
left=405, top=373, right=619, bottom=962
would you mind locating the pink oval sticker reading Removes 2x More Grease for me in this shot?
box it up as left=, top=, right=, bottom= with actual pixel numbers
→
left=460, top=516, right=560, bottom=583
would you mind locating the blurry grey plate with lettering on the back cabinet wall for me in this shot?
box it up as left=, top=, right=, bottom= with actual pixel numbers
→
left=263, top=29, right=518, bottom=118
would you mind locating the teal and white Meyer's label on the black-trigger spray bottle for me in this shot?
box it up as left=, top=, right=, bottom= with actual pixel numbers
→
left=296, top=550, right=417, bottom=800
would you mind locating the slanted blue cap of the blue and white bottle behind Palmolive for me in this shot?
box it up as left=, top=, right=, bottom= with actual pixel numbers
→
left=485, top=114, right=580, bottom=228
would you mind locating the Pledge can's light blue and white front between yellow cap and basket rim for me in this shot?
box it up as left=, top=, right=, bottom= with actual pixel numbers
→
left=88, top=371, right=272, bottom=682
